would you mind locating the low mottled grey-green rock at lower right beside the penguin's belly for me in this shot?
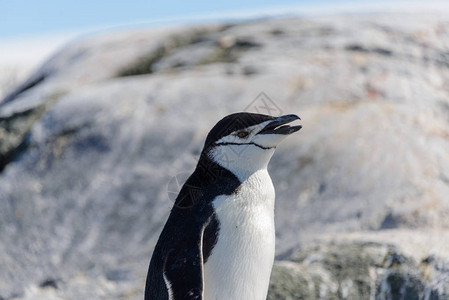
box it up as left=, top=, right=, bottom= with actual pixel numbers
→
left=268, top=241, right=449, bottom=300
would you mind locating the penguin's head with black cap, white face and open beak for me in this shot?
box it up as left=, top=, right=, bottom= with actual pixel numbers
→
left=203, top=112, right=302, bottom=175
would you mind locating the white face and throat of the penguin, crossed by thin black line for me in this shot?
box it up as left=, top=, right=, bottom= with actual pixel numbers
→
left=209, top=121, right=288, bottom=179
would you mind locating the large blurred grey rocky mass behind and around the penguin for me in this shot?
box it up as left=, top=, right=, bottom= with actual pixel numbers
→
left=0, top=13, right=449, bottom=300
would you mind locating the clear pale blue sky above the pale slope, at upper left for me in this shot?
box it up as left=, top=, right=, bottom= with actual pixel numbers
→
left=0, top=0, right=328, bottom=39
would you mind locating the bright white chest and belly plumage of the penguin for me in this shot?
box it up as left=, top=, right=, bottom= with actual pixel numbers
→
left=204, top=170, right=275, bottom=300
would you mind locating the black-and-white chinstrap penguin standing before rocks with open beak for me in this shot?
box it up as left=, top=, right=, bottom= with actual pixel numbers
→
left=145, top=112, right=302, bottom=300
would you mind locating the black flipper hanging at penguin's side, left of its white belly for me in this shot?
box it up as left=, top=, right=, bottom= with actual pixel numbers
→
left=164, top=227, right=203, bottom=300
